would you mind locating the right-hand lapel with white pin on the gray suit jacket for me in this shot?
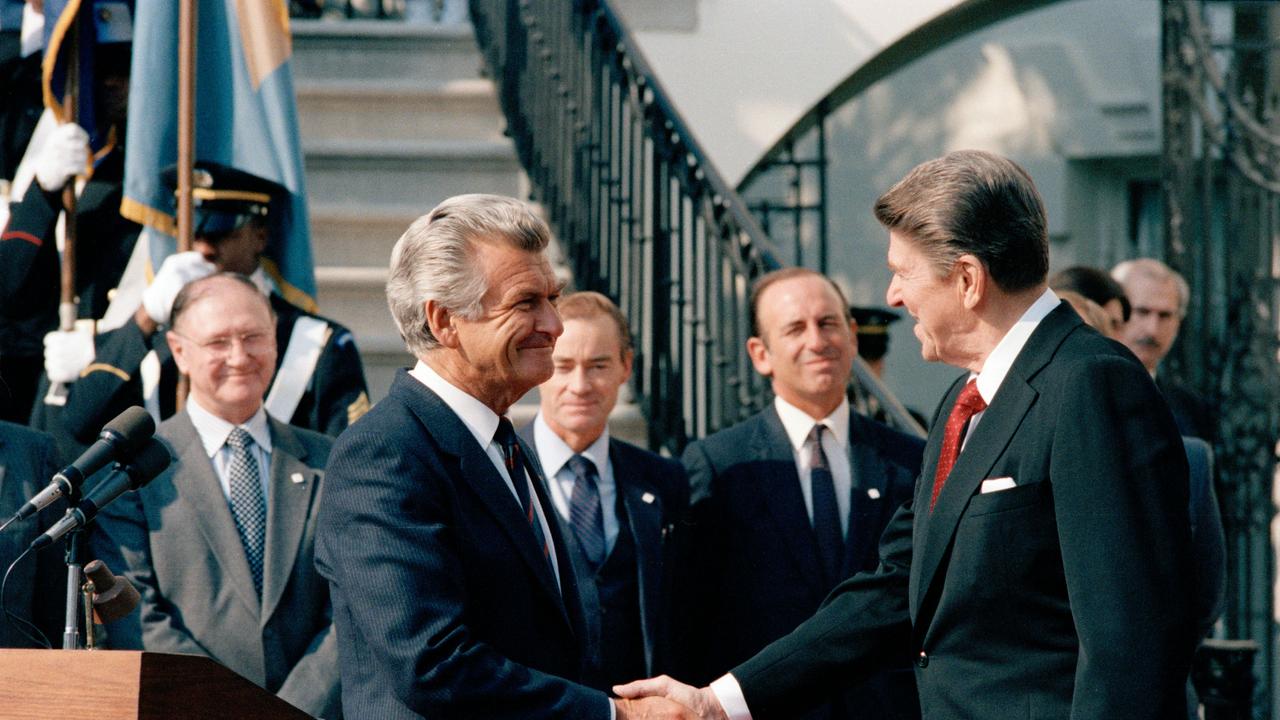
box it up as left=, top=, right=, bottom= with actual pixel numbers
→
left=262, top=418, right=320, bottom=618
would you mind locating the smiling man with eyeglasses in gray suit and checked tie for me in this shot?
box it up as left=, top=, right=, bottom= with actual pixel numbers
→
left=90, top=273, right=340, bottom=717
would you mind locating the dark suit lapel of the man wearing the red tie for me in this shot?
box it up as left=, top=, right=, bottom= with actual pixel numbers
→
left=911, top=302, right=1080, bottom=616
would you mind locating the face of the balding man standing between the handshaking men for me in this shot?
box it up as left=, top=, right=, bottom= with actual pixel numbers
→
left=746, top=275, right=858, bottom=418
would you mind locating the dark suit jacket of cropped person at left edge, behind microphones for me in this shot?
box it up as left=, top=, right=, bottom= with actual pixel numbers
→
left=0, top=421, right=67, bottom=647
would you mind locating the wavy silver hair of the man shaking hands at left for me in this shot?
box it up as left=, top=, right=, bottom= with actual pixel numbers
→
left=387, top=193, right=550, bottom=357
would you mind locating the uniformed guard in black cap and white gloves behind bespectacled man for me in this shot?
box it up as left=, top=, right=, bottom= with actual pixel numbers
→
left=38, top=163, right=369, bottom=456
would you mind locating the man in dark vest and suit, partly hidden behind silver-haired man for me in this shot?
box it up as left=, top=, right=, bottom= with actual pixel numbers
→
left=521, top=292, right=689, bottom=688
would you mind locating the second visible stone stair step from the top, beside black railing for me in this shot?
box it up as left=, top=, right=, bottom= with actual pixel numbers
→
left=296, top=78, right=506, bottom=143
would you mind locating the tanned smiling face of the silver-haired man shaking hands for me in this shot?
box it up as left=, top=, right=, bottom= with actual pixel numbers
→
left=451, top=242, right=564, bottom=407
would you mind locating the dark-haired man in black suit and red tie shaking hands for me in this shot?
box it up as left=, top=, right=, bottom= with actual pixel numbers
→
left=616, top=150, right=1197, bottom=720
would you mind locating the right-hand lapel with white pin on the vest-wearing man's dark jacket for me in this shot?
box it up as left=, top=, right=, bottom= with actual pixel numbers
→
left=609, top=439, right=663, bottom=673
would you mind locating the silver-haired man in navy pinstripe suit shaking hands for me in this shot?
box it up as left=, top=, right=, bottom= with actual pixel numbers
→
left=316, top=195, right=689, bottom=720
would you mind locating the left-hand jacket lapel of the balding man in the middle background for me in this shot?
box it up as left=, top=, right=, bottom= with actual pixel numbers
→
left=751, top=405, right=826, bottom=596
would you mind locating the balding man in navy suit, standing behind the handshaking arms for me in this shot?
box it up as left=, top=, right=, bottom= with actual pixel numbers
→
left=681, top=268, right=924, bottom=720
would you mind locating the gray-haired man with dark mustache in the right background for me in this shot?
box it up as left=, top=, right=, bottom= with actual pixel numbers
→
left=1111, top=258, right=1217, bottom=445
